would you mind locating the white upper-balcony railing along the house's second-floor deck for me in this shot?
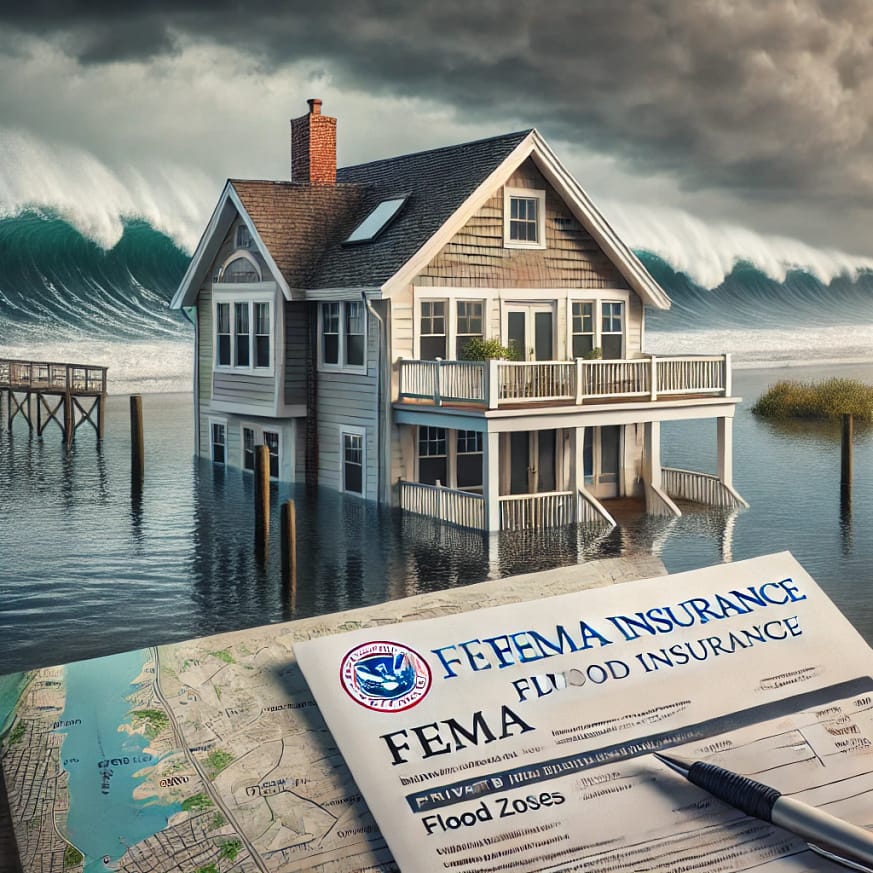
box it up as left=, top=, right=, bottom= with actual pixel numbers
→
left=400, top=355, right=731, bottom=409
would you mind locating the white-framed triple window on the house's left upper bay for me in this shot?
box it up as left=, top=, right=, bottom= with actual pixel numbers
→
left=214, top=291, right=273, bottom=374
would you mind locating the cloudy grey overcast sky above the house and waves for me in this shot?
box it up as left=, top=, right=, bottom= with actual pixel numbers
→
left=0, top=0, right=873, bottom=282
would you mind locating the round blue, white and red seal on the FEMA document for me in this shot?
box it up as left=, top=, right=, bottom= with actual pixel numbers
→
left=340, top=640, right=431, bottom=712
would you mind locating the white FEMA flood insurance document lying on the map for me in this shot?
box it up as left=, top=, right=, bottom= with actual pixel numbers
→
left=295, top=552, right=873, bottom=873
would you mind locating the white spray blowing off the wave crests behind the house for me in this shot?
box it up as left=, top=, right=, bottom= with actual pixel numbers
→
left=0, top=127, right=873, bottom=288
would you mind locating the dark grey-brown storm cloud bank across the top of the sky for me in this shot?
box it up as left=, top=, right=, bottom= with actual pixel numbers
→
left=0, top=0, right=873, bottom=216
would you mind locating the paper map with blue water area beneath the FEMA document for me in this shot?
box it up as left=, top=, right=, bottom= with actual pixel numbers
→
left=0, top=558, right=663, bottom=873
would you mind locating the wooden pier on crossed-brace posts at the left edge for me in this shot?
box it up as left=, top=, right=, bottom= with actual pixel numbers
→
left=0, top=358, right=106, bottom=446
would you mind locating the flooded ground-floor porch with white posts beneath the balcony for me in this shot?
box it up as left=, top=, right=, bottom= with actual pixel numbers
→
left=397, top=417, right=747, bottom=531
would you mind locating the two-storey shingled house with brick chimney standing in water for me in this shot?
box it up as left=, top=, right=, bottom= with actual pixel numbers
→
left=173, top=100, right=742, bottom=530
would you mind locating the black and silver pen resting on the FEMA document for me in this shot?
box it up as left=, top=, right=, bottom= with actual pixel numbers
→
left=654, top=752, right=873, bottom=873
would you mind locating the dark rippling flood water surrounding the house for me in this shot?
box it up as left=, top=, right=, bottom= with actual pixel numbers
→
left=0, top=365, right=873, bottom=674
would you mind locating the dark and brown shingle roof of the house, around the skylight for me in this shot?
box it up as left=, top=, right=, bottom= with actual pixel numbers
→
left=232, top=130, right=531, bottom=290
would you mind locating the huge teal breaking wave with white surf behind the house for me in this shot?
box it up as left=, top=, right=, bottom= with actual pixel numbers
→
left=0, top=208, right=873, bottom=392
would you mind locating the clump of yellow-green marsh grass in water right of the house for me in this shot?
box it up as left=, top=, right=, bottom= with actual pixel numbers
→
left=752, top=378, right=873, bottom=421
